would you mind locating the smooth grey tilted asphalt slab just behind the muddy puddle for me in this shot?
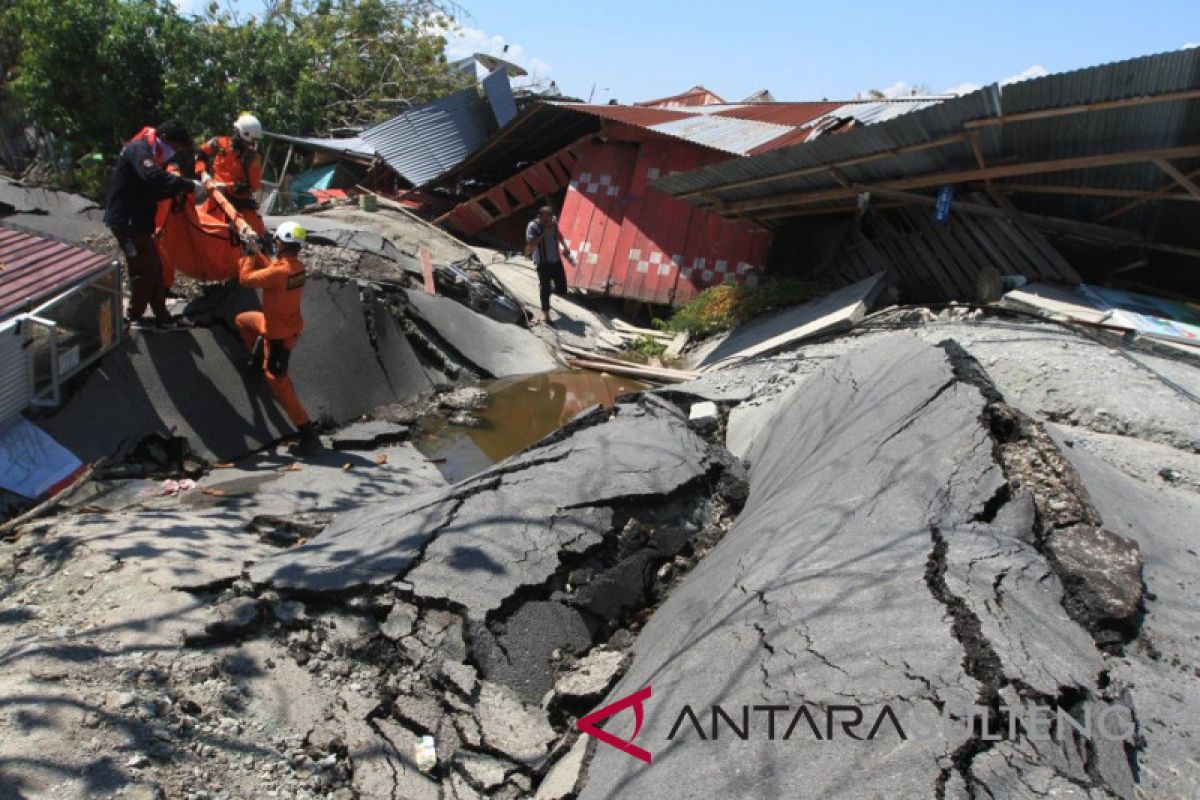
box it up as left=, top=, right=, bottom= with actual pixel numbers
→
left=404, top=290, right=562, bottom=378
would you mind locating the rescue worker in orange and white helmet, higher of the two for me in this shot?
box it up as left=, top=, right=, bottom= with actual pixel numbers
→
left=196, top=113, right=266, bottom=235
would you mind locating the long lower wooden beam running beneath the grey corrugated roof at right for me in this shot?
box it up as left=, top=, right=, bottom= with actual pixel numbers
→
left=716, top=145, right=1200, bottom=215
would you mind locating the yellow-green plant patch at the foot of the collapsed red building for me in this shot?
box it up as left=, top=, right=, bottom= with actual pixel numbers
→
left=654, top=279, right=829, bottom=337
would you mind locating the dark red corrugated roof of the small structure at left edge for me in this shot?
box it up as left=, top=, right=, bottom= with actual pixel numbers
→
left=0, top=225, right=113, bottom=318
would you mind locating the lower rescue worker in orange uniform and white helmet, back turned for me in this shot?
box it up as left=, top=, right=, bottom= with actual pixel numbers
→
left=234, top=221, right=320, bottom=456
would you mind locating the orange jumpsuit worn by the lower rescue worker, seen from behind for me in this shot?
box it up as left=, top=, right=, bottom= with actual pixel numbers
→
left=234, top=253, right=308, bottom=428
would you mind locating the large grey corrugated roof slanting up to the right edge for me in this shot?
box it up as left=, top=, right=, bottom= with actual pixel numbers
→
left=655, top=49, right=1200, bottom=231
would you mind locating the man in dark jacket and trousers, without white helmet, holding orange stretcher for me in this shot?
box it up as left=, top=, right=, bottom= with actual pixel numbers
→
left=104, top=120, right=205, bottom=329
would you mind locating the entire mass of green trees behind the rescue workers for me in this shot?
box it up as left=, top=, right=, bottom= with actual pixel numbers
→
left=0, top=0, right=470, bottom=160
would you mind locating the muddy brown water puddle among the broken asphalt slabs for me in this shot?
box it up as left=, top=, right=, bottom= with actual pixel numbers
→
left=414, top=369, right=647, bottom=482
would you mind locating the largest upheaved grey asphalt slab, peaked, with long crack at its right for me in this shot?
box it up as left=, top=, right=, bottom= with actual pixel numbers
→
left=580, top=335, right=1128, bottom=799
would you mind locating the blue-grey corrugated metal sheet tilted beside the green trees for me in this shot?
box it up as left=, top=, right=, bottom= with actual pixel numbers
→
left=362, top=88, right=487, bottom=186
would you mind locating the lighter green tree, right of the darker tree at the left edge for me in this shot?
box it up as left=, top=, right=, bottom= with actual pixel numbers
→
left=164, top=0, right=470, bottom=139
